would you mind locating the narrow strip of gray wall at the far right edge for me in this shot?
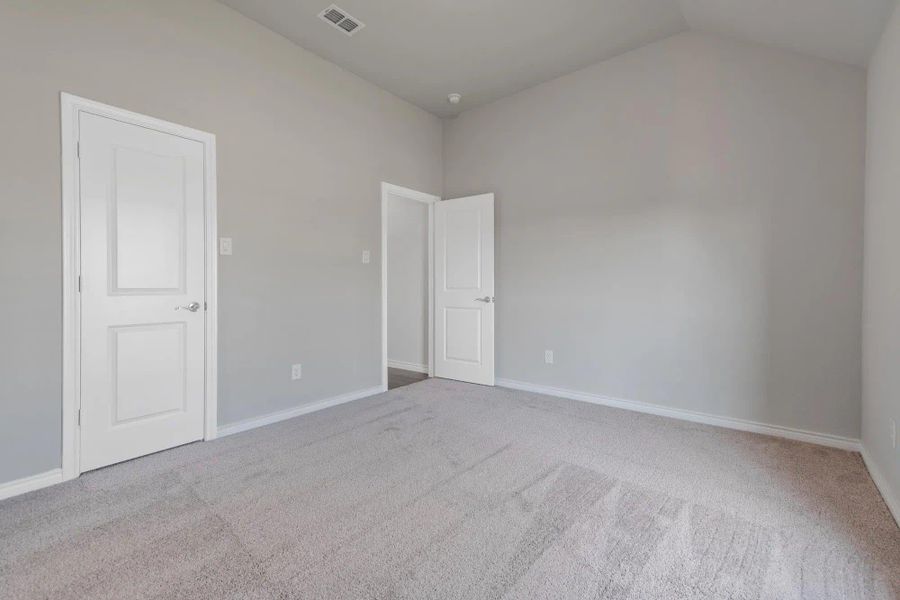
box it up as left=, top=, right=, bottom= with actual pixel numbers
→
left=862, top=1, right=900, bottom=510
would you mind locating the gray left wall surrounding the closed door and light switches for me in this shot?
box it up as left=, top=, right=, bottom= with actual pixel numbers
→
left=0, top=0, right=441, bottom=482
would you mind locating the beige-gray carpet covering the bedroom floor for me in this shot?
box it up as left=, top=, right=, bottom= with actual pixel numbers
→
left=0, top=380, right=900, bottom=600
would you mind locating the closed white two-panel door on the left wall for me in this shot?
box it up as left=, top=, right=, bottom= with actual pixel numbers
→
left=79, top=113, right=205, bottom=471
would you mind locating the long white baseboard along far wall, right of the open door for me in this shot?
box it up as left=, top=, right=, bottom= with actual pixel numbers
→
left=497, top=379, right=861, bottom=452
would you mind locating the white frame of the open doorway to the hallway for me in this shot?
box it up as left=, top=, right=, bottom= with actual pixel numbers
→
left=381, top=181, right=440, bottom=391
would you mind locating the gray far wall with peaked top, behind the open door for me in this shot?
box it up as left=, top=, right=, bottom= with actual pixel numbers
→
left=443, top=33, right=866, bottom=438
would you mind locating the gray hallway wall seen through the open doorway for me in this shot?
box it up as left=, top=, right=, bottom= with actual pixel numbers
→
left=387, top=195, right=428, bottom=365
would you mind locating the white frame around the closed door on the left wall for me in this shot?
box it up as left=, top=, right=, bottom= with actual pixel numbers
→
left=60, top=92, right=218, bottom=481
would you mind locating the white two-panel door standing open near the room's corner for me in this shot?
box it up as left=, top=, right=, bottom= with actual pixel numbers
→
left=434, top=194, right=494, bottom=385
